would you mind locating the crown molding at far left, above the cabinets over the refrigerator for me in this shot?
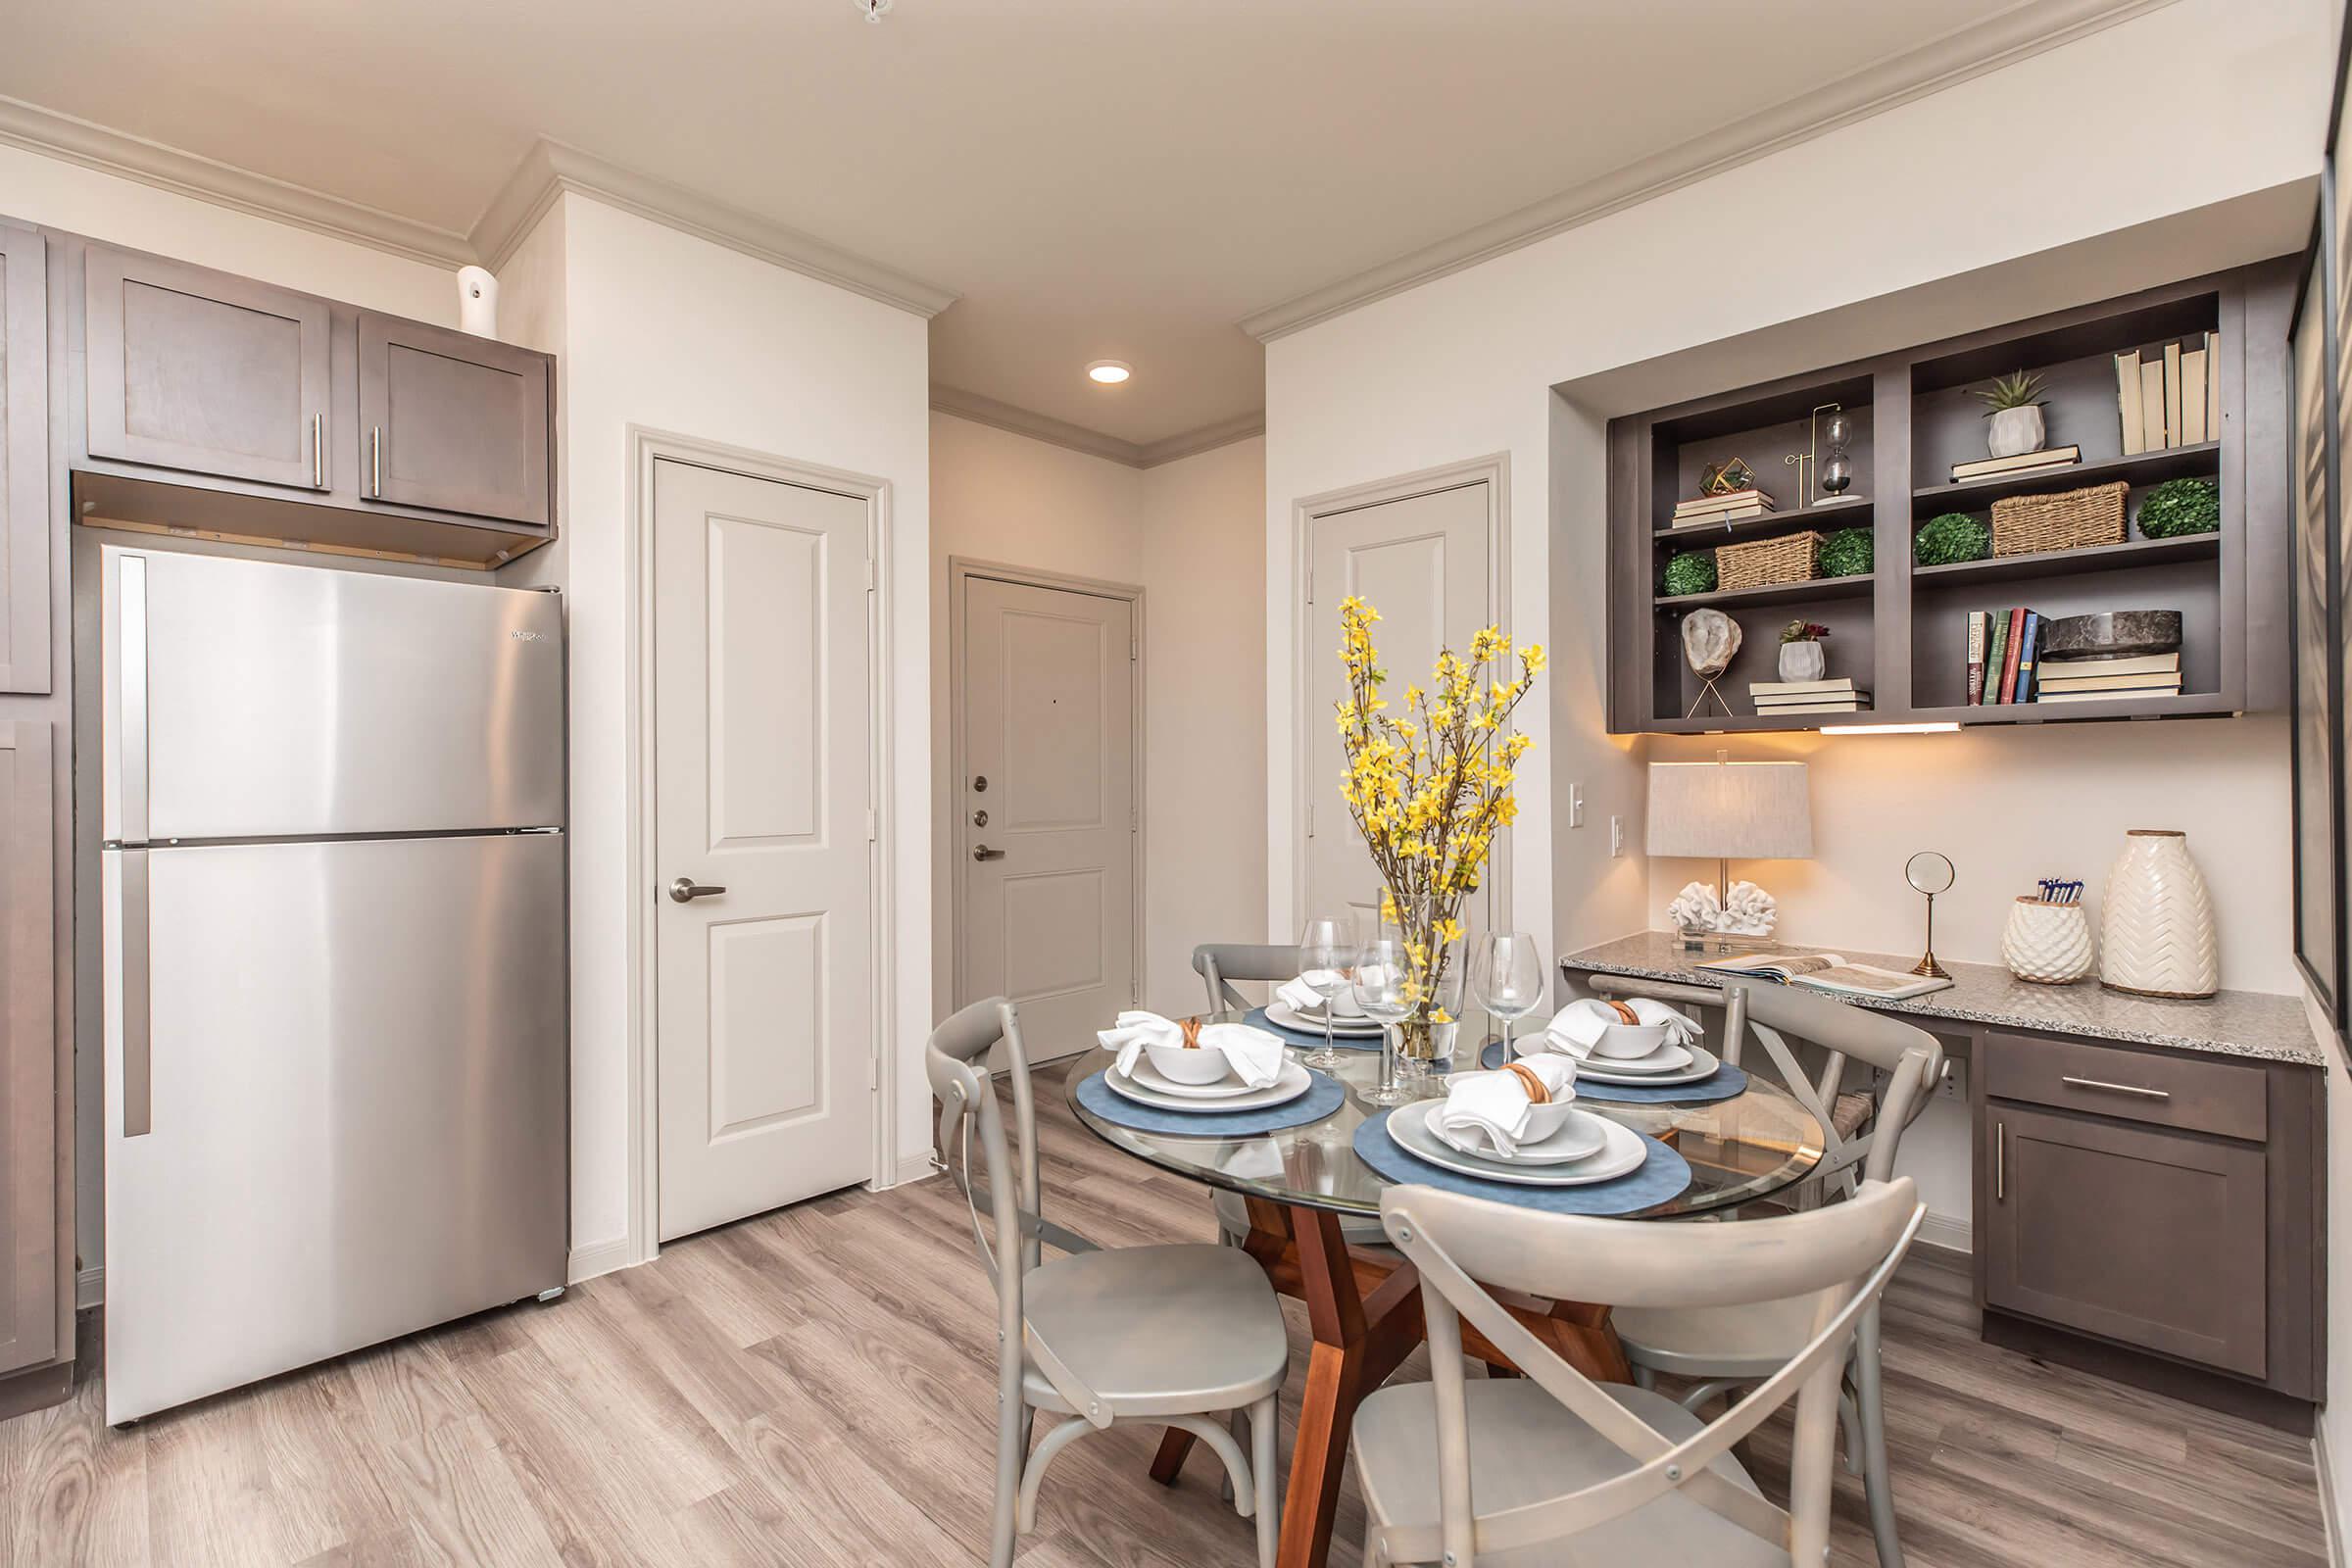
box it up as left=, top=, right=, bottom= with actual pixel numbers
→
left=0, top=99, right=472, bottom=266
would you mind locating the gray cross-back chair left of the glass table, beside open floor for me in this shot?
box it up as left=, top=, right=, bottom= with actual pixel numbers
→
left=924, top=997, right=1292, bottom=1568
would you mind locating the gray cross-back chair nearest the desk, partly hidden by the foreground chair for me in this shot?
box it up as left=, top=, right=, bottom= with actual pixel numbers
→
left=1609, top=983, right=1942, bottom=1568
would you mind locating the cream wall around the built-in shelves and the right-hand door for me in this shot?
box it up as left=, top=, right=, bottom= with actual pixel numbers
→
left=1265, top=0, right=2330, bottom=985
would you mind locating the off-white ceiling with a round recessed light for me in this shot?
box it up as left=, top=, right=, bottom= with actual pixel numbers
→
left=0, top=0, right=2138, bottom=444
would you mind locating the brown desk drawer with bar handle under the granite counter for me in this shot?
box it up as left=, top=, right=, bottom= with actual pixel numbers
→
left=1983, top=1032, right=2270, bottom=1143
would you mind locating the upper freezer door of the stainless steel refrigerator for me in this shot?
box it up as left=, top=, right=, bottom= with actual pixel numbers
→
left=101, top=546, right=564, bottom=842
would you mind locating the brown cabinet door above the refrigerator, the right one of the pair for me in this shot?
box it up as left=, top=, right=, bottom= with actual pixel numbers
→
left=360, top=311, right=548, bottom=526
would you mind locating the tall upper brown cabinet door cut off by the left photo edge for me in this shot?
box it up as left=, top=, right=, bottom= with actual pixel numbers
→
left=0, top=223, right=49, bottom=694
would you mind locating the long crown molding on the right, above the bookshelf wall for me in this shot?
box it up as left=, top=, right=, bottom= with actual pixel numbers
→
left=1240, top=0, right=2174, bottom=343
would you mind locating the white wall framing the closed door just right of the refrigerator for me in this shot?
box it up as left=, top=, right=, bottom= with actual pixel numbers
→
left=543, top=195, right=931, bottom=1272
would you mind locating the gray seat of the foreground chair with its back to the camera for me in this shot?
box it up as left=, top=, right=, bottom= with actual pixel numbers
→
left=1354, top=1378, right=1789, bottom=1568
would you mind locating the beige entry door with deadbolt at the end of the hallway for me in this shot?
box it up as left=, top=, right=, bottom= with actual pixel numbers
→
left=955, top=578, right=1136, bottom=1060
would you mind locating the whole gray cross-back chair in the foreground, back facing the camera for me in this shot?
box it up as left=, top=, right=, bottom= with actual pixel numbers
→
left=1352, top=1178, right=1927, bottom=1568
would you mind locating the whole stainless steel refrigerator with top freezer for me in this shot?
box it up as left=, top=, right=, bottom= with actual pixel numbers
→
left=99, top=548, right=569, bottom=1422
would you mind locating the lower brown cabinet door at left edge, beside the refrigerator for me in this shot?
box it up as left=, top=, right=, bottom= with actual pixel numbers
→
left=0, top=721, right=59, bottom=1373
